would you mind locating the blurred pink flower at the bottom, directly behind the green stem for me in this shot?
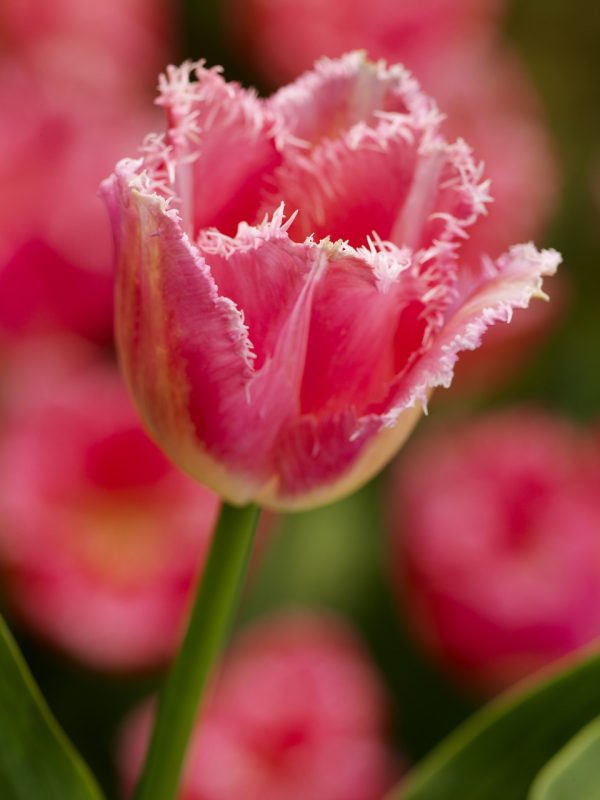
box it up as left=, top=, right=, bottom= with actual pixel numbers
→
left=120, top=613, right=397, bottom=800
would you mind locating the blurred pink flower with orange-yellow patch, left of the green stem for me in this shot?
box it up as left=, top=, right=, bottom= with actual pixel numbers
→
left=0, top=342, right=217, bottom=670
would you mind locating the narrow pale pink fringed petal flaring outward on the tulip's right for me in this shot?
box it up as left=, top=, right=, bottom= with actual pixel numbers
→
left=386, top=243, right=561, bottom=424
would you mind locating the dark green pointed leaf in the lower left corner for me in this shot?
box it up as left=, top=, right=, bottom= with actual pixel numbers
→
left=0, top=618, right=102, bottom=800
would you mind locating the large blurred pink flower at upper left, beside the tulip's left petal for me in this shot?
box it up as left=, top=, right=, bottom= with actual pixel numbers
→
left=0, top=60, right=162, bottom=342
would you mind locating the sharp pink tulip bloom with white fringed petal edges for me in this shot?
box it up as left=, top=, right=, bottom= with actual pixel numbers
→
left=104, top=53, right=560, bottom=508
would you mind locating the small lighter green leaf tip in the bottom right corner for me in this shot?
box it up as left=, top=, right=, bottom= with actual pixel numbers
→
left=529, top=717, right=600, bottom=800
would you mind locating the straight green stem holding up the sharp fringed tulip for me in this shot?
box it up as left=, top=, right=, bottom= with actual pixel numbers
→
left=135, top=503, right=259, bottom=800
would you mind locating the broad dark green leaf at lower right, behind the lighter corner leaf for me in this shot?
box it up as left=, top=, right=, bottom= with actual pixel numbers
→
left=388, top=651, right=600, bottom=800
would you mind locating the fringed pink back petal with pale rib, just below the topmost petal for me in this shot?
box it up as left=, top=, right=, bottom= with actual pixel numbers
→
left=264, top=114, right=490, bottom=249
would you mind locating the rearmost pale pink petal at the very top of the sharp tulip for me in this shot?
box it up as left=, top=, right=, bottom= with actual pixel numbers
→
left=265, top=51, right=440, bottom=148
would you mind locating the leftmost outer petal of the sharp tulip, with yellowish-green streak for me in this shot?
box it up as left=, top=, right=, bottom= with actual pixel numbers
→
left=103, top=161, right=270, bottom=496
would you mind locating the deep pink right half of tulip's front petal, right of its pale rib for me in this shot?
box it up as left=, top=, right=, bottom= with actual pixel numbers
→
left=300, top=242, right=453, bottom=417
